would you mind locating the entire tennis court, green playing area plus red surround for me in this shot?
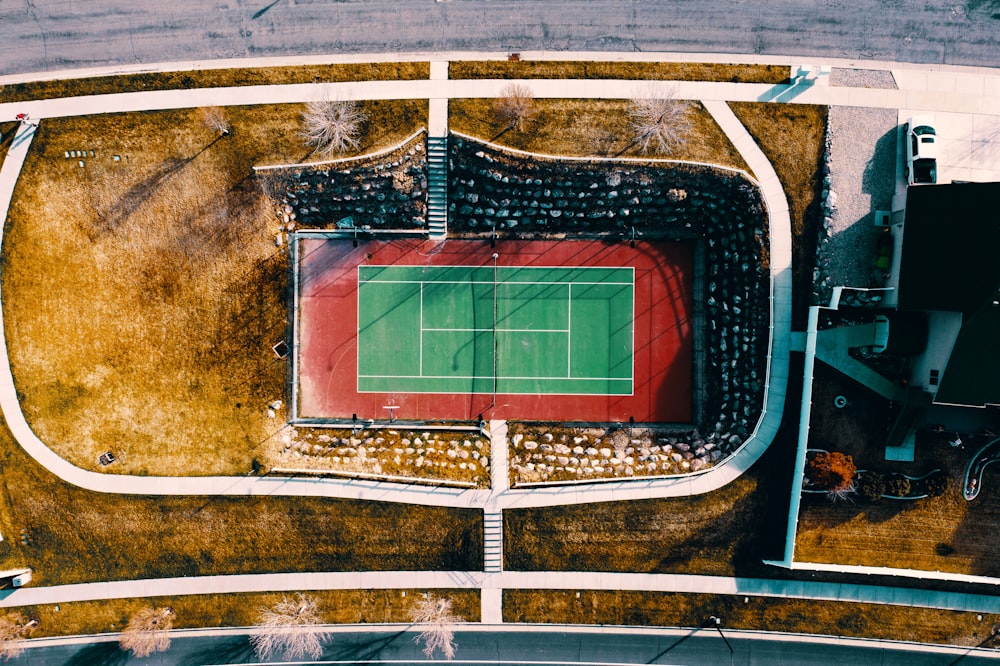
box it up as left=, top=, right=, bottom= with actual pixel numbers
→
left=293, top=240, right=694, bottom=423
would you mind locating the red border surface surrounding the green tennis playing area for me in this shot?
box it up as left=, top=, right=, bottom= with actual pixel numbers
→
left=295, top=238, right=693, bottom=423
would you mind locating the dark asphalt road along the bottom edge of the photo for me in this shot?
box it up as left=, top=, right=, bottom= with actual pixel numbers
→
left=8, top=629, right=1000, bottom=666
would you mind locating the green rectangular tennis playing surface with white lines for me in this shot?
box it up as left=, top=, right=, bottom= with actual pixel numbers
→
left=358, top=266, right=634, bottom=395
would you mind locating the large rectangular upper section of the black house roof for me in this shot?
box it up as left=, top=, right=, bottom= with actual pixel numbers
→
left=898, top=183, right=1000, bottom=315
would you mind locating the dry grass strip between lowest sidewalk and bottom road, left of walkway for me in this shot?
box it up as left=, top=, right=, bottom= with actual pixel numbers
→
left=4, top=589, right=480, bottom=638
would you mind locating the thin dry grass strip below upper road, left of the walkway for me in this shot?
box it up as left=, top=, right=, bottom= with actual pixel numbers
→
left=0, top=62, right=430, bottom=102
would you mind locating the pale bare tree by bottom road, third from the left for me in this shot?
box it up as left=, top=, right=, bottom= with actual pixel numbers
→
left=250, top=593, right=331, bottom=661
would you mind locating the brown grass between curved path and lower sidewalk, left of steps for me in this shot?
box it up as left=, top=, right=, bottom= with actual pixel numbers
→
left=0, top=418, right=483, bottom=585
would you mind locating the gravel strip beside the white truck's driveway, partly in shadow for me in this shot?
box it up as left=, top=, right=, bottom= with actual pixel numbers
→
left=813, top=106, right=897, bottom=304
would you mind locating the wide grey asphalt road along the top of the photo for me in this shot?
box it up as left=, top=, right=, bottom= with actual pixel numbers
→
left=0, top=0, right=1000, bottom=74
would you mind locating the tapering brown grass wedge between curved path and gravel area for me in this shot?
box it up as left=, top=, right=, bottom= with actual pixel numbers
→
left=729, top=102, right=827, bottom=330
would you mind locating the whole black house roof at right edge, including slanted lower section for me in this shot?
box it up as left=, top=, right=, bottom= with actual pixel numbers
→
left=898, top=183, right=1000, bottom=406
